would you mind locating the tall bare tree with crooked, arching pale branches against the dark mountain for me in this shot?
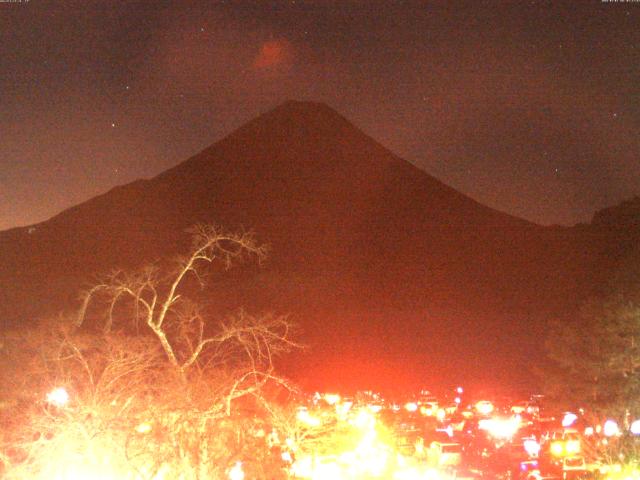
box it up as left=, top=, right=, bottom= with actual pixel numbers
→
left=76, top=225, right=298, bottom=408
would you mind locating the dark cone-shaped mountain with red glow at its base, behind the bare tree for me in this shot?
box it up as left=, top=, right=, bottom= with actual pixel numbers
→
left=0, top=102, right=640, bottom=394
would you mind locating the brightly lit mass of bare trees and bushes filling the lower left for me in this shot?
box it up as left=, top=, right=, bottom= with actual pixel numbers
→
left=0, top=225, right=297, bottom=479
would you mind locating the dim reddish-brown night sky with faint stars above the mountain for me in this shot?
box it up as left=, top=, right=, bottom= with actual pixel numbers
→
left=0, top=0, right=640, bottom=230
